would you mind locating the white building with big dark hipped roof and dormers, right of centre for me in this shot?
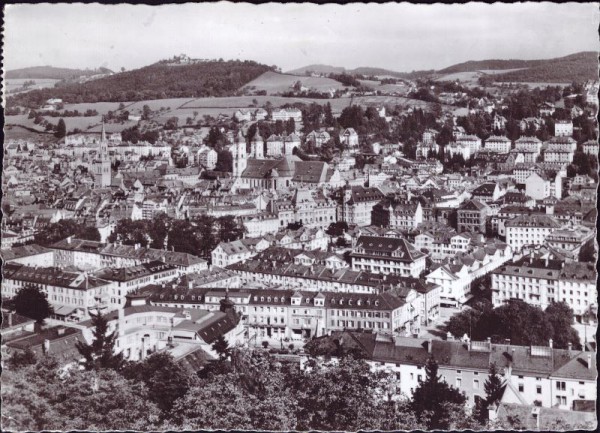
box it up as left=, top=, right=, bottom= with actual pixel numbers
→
left=350, top=236, right=427, bottom=278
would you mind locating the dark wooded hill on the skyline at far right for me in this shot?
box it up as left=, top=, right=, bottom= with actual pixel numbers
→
left=437, top=51, right=598, bottom=82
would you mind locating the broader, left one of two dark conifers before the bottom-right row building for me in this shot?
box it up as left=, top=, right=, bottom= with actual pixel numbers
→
left=411, top=357, right=466, bottom=430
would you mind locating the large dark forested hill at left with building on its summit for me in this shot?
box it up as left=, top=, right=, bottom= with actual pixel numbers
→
left=7, top=60, right=272, bottom=108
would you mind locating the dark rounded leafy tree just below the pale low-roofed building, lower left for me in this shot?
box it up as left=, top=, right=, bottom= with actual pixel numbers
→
left=123, top=352, right=190, bottom=412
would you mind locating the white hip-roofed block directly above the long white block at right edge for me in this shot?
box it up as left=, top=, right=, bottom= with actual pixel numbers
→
left=504, top=215, right=560, bottom=251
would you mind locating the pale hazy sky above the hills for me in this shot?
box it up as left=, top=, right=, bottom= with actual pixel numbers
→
left=4, top=2, right=600, bottom=72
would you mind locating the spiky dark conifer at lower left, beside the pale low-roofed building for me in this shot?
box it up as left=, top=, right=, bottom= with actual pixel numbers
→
left=76, top=313, right=124, bottom=370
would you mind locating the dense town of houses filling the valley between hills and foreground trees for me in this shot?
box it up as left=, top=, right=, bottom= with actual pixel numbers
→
left=1, top=81, right=598, bottom=418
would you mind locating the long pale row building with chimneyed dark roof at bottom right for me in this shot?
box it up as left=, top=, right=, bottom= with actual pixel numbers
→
left=315, top=331, right=597, bottom=411
